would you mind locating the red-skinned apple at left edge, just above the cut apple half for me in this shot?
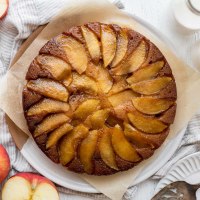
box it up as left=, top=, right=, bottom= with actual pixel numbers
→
left=0, top=145, right=10, bottom=183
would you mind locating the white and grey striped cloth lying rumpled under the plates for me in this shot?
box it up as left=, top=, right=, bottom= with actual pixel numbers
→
left=0, top=0, right=200, bottom=200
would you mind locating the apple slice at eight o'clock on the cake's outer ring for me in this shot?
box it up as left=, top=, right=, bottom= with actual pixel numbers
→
left=33, top=113, right=69, bottom=137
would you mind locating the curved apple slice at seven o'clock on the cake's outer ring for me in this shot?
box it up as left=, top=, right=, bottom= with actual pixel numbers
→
left=59, top=124, right=88, bottom=165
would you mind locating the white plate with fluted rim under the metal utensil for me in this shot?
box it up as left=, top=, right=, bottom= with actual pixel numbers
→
left=155, top=152, right=200, bottom=194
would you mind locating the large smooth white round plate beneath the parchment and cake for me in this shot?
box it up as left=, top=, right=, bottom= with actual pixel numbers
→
left=21, top=15, right=185, bottom=193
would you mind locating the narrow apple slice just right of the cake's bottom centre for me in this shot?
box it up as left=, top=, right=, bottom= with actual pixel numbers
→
left=99, top=128, right=119, bottom=170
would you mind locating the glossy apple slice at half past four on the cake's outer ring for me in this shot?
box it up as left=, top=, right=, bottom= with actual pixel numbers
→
left=124, top=122, right=154, bottom=148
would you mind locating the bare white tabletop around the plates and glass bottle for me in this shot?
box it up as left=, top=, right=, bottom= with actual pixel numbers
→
left=121, top=0, right=200, bottom=200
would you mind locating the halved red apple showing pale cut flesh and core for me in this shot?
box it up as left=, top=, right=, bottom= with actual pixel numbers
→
left=2, top=173, right=59, bottom=200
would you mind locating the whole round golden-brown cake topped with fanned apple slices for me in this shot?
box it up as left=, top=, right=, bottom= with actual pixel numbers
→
left=23, top=22, right=177, bottom=175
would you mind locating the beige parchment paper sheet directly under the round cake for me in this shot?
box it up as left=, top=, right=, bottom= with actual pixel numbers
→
left=0, top=0, right=200, bottom=200
